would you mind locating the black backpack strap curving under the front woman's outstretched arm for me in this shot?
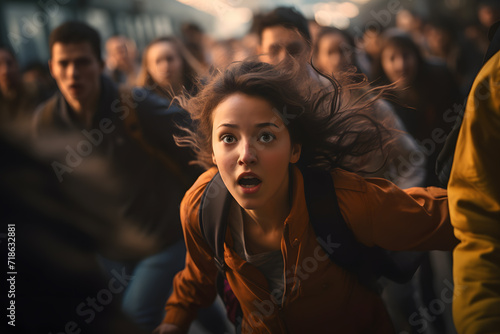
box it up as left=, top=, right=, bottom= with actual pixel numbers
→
left=302, top=169, right=423, bottom=287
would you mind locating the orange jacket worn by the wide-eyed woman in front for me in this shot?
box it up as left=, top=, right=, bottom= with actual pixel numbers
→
left=163, top=168, right=457, bottom=334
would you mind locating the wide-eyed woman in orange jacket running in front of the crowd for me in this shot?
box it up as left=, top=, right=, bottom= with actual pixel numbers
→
left=155, top=58, right=456, bottom=333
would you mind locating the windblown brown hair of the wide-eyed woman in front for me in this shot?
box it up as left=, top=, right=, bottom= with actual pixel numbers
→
left=176, top=57, right=390, bottom=173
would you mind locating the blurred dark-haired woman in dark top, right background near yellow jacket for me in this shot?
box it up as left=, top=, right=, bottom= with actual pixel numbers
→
left=373, top=29, right=459, bottom=186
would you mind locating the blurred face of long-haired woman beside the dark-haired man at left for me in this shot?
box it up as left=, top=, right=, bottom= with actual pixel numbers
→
left=146, top=41, right=184, bottom=91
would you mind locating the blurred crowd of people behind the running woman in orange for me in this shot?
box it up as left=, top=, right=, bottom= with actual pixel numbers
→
left=0, top=2, right=500, bottom=333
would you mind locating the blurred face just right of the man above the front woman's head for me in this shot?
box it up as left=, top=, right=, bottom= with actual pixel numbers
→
left=316, top=33, right=354, bottom=74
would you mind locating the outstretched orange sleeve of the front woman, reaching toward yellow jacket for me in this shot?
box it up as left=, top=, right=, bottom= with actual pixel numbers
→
left=333, top=170, right=458, bottom=251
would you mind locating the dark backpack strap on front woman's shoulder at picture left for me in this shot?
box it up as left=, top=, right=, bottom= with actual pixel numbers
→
left=199, top=173, right=233, bottom=272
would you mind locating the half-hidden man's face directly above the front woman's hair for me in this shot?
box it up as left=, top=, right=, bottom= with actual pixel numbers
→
left=258, top=26, right=311, bottom=64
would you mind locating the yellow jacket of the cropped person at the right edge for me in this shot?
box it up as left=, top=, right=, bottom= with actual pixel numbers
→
left=448, top=52, right=500, bottom=334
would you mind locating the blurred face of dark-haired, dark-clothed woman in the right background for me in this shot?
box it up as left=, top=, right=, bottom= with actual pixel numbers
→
left=380, top=44, right=418, bottom=87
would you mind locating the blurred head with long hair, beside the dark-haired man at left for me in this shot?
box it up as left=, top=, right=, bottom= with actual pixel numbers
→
left=137, top=37, right=203, bottom=99
